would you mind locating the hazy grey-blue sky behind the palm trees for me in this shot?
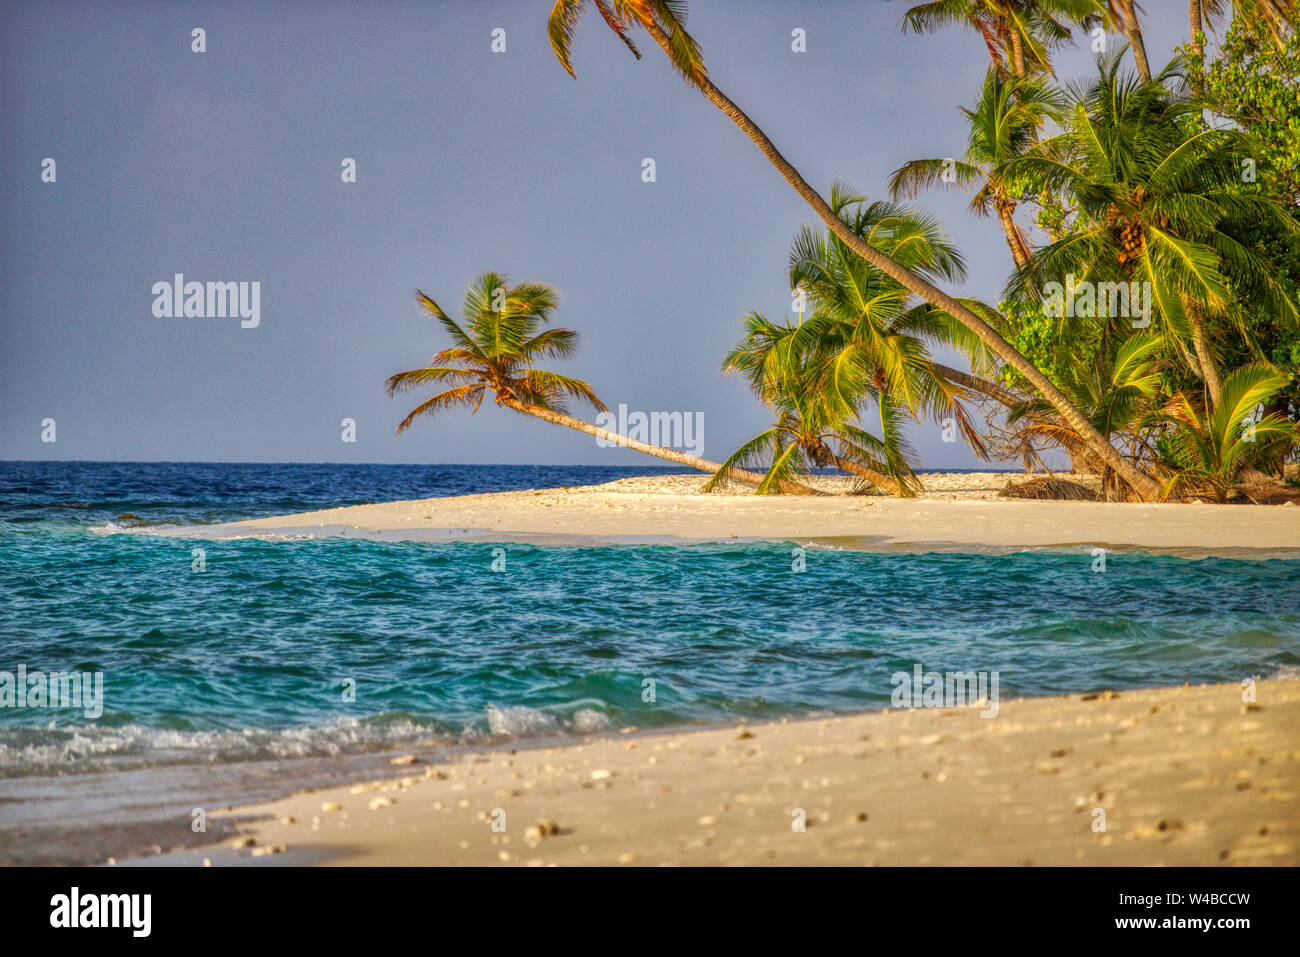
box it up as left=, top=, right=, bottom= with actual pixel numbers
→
left=0, top=0, right=1187, bottom=468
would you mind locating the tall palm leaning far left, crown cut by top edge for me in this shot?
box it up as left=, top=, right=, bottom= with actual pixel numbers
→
left=550, top=0, right=1160, bottom=499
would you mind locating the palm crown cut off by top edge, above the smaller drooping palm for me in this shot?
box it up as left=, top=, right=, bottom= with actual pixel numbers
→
left=902, top=0, right=1105, bottom=77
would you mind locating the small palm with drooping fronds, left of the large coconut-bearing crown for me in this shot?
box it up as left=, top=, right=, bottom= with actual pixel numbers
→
left=889, top=69, right=1061, bottom=267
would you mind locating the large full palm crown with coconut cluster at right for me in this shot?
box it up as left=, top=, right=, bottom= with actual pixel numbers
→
left=1001, top=53, right=1297, bottom=404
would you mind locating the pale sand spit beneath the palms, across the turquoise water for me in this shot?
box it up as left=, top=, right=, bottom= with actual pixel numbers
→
left=169, top=472, right=1300, bottom=554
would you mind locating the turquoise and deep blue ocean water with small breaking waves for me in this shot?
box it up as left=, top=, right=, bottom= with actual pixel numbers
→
left=0, top=462, right=1300, bottom=863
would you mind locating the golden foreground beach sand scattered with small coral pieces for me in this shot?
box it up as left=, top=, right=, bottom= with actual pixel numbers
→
left=157, top=680, right=1300, bottom=866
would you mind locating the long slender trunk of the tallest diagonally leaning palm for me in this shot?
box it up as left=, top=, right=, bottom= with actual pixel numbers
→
left=640, top=20, right=1160, bottom=501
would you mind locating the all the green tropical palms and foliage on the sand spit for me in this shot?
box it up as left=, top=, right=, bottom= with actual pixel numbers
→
left=389, top=0, right=1300, bottom=501
